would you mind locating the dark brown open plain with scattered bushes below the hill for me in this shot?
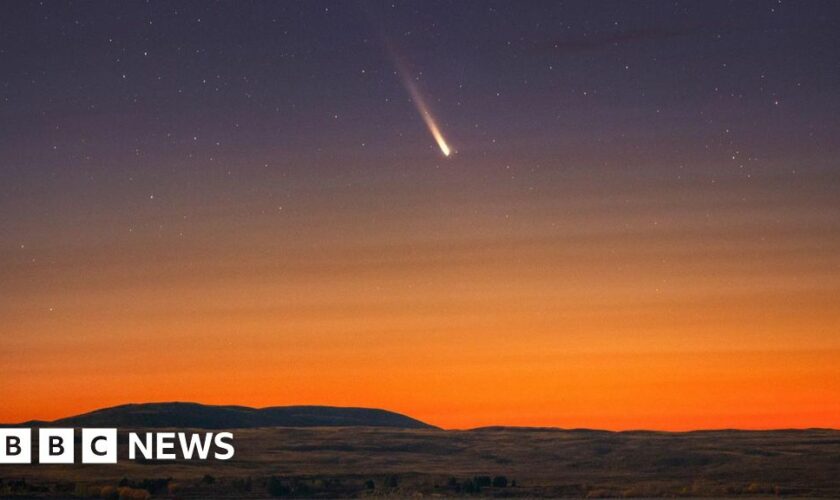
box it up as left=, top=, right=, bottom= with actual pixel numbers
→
left=0, top=427, right=840, bottom=498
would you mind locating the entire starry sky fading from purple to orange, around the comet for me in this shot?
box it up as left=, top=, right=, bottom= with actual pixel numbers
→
left=0, top=1, right=840, bottom=429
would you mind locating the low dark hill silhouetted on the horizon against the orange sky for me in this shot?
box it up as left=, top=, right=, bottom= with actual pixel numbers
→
left=9, top=402, right=436, bottom=429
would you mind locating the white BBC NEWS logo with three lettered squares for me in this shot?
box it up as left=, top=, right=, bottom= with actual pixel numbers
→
left=0, top=428, right=235, bottom=464
